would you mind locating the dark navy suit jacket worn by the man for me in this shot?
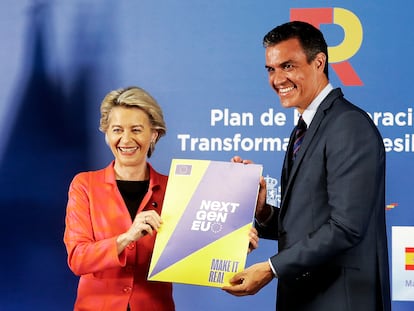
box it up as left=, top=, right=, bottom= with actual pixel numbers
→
left=258, top=89, right=391, bottom=311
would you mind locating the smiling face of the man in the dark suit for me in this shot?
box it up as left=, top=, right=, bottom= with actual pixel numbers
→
left=266, top=38, right=327, bottom=113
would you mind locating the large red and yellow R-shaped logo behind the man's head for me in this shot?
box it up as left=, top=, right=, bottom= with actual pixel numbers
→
left=290, top=8, right=363, bottom=86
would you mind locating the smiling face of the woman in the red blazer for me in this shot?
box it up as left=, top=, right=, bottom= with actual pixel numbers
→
left=105, top=107, right=157, bottom=171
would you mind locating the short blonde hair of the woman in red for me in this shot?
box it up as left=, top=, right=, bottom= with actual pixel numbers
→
left=99, top=86, right=167, bottom=158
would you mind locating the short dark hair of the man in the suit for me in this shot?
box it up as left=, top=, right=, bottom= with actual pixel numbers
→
left=263, top=21, right=329, bottom=78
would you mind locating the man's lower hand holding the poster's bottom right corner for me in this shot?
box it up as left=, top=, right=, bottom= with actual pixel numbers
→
left=222, top=261, right=274, bottom=296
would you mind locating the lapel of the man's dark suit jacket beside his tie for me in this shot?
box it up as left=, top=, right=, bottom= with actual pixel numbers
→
left=280, top=88, right=343, bottom=215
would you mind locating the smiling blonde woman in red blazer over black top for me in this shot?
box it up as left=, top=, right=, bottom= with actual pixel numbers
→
left=64, top=87, right=174, bottom=311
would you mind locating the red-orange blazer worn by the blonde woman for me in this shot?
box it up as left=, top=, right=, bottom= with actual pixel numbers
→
left=64, top=162, right=175, bottom=311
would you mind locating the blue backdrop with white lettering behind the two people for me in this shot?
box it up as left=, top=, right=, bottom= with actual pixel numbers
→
left=0, top=0, right=414, bottom=311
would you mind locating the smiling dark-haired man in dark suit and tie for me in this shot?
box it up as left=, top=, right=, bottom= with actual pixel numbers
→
left=223, top=21, right=391, bottom=311
